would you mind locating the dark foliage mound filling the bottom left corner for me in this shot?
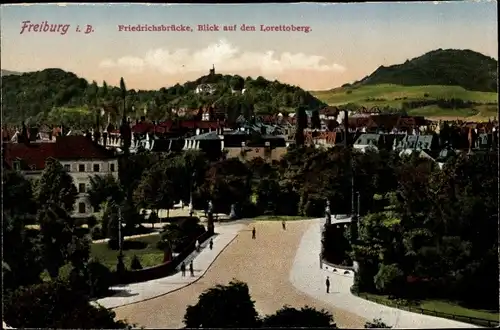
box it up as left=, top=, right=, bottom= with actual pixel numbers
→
left=3, top=281, right=128, bottom=329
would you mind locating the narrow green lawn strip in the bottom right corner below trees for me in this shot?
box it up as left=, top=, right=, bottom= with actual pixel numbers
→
left=361, top=293, right=500, bottom=326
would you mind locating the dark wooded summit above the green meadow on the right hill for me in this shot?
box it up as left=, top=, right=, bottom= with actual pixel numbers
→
left=353, top=49, right=498, bottom=92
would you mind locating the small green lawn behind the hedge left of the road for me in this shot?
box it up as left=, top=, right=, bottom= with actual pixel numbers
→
left=91, top=235, right=163, bottom=271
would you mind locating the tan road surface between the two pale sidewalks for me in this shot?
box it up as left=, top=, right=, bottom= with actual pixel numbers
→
left=114, top=220, right=366, bottom=328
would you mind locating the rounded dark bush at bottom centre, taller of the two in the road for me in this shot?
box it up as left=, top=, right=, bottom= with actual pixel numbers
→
left=184, top=280, right=259, bottom=328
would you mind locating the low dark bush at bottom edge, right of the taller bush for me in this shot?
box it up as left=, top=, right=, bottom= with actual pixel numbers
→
left=262, top=306, right=336, bottom=328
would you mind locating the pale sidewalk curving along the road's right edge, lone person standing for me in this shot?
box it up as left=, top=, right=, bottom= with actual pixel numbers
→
left=290, top=219, right=477, bottom=328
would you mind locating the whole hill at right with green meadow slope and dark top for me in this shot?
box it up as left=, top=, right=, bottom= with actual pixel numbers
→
left=311, top=50, right=498, bottom=120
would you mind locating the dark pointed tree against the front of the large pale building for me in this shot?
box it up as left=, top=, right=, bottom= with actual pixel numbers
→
left=36, top=158, right=77, bottom=214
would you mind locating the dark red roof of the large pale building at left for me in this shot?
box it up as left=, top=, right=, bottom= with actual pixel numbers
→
left=4, top=136, right=113, bottom=170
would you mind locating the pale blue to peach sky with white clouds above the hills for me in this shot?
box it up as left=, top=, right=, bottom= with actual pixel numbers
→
left=0, top=1, right=498, bottom=90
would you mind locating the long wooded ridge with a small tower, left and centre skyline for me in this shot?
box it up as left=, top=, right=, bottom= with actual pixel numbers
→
left=2, top=69, right=325, bottom=124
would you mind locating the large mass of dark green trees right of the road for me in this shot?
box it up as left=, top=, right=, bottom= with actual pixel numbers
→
left=353, top=152, right=498, bottom=310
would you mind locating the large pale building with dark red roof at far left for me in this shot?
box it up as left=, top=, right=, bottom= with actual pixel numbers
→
left=4, top=136, right=118, bottom=218
